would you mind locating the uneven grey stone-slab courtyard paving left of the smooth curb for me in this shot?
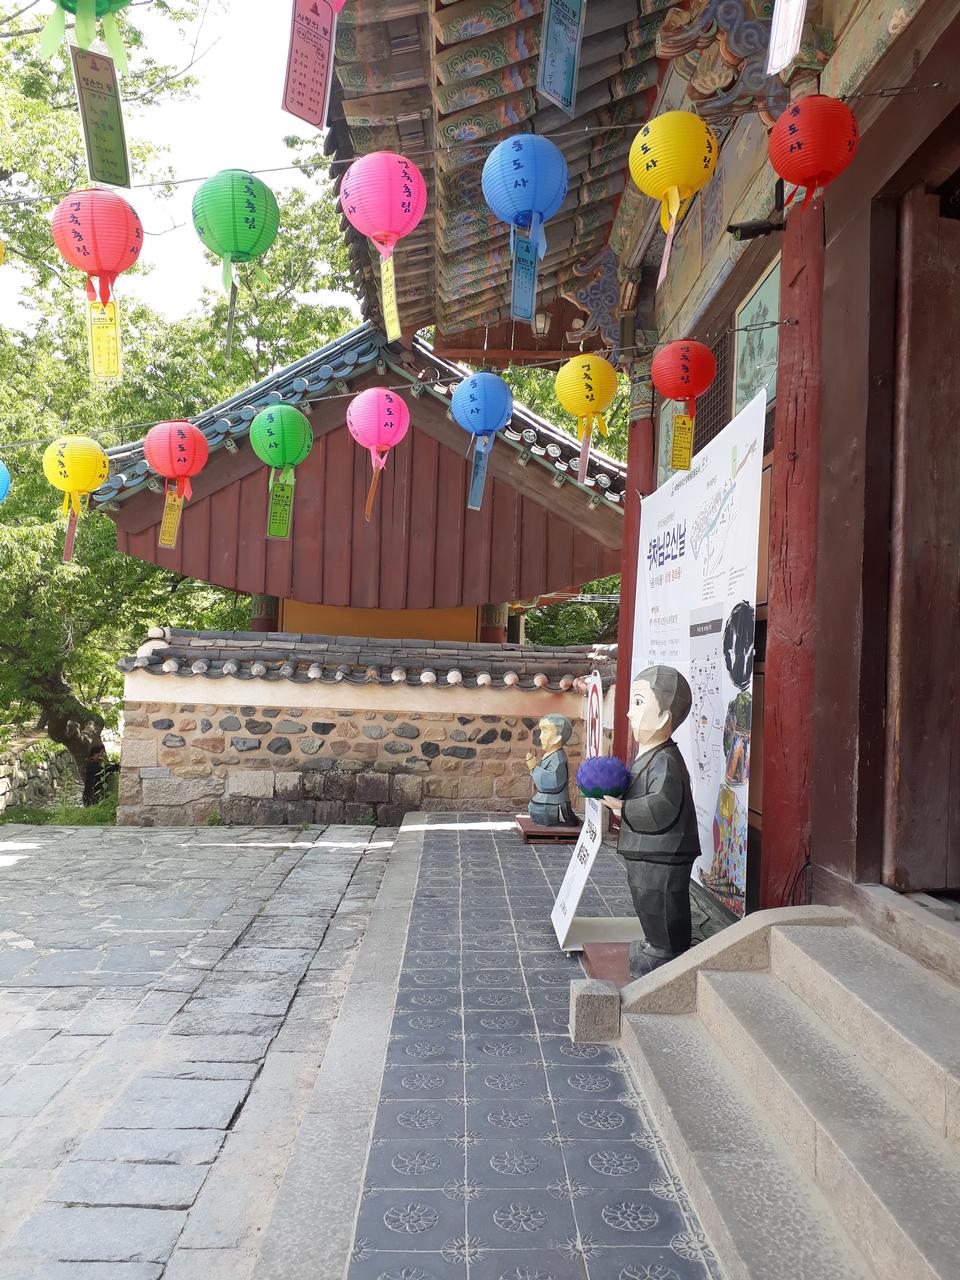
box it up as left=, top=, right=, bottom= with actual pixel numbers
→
left=0, top=827, right=393, bottom=1280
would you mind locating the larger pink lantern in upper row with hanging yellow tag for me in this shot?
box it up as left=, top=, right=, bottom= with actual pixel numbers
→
left=340, top=151, right=426, bottom=342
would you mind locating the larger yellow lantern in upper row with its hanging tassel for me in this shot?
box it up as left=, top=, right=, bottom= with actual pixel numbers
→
left=630, top=111, right=719, bottom=289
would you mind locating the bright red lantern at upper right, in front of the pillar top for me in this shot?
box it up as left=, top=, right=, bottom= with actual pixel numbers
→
left=767, top=93, right=860, bottom=209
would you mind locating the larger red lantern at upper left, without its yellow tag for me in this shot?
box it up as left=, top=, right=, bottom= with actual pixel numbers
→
left=54, top=188, right=143, bottom=306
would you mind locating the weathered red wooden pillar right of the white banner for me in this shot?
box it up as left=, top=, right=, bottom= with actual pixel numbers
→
left=760, top=200, right=824, bottom=906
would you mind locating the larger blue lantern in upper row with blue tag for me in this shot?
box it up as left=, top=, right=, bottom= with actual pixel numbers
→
left=481, top=133, right=567, bottom=324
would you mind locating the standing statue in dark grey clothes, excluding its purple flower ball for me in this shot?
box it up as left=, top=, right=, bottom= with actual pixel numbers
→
left=603, top=667, right=700, bottom=978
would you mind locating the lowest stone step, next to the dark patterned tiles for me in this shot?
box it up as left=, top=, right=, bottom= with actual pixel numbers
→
left=621, top=1014, right=873, bottom=1280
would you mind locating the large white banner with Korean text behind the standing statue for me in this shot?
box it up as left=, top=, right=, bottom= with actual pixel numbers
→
left=632, top=390, right=767, bottom=915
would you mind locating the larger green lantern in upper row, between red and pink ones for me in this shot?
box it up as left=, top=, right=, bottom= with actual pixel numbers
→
left=193, top=169, right=280, bottom=292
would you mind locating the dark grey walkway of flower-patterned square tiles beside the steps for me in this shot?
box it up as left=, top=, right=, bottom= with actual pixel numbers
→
left=343, top=817, right=716, bottom=1280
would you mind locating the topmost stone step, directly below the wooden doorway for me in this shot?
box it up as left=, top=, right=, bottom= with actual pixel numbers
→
left=771, top=925, right=960, bottom=1151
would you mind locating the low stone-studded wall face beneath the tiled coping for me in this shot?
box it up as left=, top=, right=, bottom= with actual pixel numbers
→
left=118, top=690, right=581, bottom=826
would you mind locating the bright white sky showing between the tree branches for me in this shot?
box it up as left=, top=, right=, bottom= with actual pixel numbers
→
left=0, top=0, right=358, bottom=324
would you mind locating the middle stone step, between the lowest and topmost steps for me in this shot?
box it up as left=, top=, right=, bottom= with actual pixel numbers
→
left=698, top=973, right=960, bottom=1280
